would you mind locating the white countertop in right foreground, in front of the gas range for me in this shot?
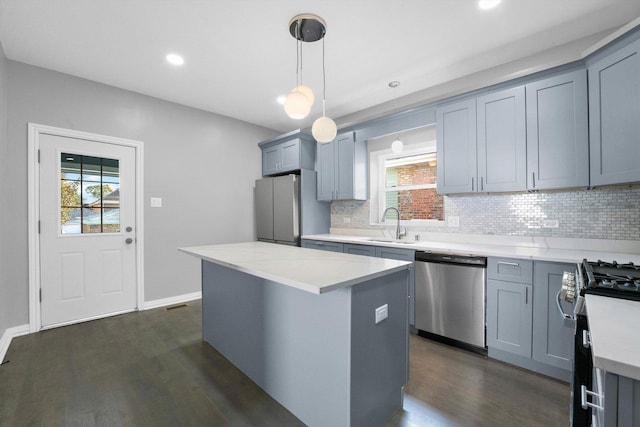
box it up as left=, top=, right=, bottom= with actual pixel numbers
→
left=586, top=295, right=640, bottom=381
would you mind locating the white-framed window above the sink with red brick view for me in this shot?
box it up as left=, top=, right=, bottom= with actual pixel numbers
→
left=370, top=141, right=444, bottom=226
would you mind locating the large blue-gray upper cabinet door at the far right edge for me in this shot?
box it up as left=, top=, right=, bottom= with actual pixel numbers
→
left=589, top=40, right=640, bottom=185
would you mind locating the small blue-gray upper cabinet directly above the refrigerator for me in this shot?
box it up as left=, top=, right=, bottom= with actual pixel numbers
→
left=259, top=130, right=315, bottom=176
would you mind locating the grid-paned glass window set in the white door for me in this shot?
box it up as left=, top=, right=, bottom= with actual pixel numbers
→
left=60, top=153, right=120, bottom=234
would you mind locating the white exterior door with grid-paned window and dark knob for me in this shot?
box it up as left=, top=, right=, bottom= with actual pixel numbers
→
left=39, top=134, right=137, bottom=328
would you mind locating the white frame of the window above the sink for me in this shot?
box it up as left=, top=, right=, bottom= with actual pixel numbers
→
left=369, top=140, right=446, bottom=227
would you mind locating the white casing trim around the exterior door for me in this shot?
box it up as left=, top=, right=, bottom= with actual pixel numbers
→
left=27, top=123, right=144, bottom=333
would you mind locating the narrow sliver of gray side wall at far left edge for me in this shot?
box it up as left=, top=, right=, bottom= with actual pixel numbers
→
left=0, top=44, right=8, bottom=337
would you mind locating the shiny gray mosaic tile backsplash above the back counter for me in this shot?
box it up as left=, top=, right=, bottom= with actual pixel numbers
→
left=331, top=187, right=640, bottom=240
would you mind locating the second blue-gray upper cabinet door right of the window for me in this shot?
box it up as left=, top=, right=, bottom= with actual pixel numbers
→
left=476, top=86, right=527, bottom=191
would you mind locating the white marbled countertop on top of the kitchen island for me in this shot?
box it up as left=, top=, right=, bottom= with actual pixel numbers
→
left=178, top=242, right=411, bottom=294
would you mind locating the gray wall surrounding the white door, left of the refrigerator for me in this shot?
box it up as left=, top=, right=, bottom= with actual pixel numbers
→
left=0, top=61, right=278, bottom=326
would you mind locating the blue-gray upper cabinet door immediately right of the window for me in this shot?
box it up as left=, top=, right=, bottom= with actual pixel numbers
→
left=436, top=99, right=477, bottom=194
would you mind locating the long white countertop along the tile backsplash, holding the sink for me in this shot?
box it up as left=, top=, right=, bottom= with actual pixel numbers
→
left=302, top=234, right=640, bottom=264
